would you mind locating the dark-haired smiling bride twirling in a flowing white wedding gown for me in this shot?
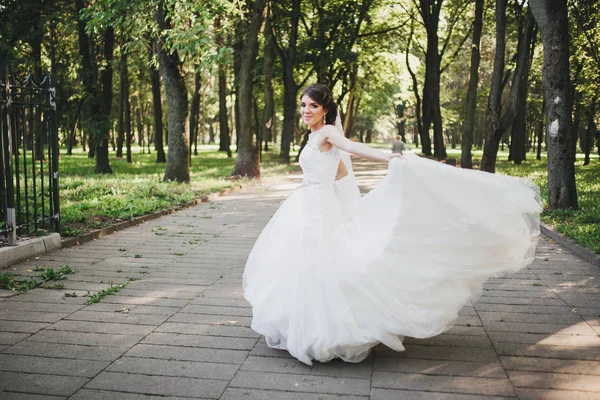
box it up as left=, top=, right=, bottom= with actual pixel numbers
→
left=243, top=84, right=541, bottom=365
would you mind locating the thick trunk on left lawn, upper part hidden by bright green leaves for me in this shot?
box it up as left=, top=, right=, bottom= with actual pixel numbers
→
left=155, top=3, right=190, bottom=183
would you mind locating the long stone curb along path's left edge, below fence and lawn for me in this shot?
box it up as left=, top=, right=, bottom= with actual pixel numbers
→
left=0, top=184, right=242, bottom=269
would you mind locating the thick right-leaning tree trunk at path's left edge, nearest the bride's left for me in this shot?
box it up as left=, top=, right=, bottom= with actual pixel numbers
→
left=233, top=0, right=265, bottom=178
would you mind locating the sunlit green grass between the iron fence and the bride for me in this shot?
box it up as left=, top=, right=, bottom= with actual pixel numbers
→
left=59, top=146, right=294, bottom=236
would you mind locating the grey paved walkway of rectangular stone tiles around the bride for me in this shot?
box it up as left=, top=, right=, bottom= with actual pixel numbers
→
left=0, top=158, right=600, bottom=400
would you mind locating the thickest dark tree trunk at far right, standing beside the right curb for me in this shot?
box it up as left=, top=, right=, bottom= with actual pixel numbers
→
left=529, top=0, right=578, bottom=210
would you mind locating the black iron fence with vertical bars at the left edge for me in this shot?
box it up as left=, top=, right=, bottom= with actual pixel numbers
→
left=0, top=65, right=60, bottom=245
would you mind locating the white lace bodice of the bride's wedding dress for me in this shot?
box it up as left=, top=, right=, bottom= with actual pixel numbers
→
left=300, top=131, right=340, bottom=186
